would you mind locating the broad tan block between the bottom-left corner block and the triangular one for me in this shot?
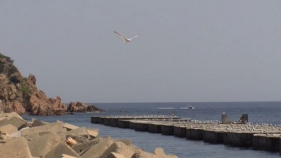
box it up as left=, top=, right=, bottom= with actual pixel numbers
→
left=28, top=132, right=60, bottom=157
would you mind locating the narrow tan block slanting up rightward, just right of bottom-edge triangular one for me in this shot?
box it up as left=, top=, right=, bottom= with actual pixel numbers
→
left=81, top=137, right=114, bottom=158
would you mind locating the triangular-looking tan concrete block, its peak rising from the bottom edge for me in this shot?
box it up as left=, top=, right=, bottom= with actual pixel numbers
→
left=43, top=142, right=80, bottom=158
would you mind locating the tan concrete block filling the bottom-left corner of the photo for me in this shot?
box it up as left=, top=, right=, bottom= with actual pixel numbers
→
left=0, top=137, right=33, bottom=158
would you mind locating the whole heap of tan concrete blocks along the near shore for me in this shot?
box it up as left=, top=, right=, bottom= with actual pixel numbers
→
left=0, top=112, right=178, bottom=158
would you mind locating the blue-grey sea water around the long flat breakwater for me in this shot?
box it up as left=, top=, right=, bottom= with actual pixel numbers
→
left=22, top=102, right=281, bottom=158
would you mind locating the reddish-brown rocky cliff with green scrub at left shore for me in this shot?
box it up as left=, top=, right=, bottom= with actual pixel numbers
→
left=0, top=53, right=67, bottom=116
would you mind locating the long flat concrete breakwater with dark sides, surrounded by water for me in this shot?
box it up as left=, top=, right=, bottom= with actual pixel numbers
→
left=91, top=115, right=281, bottom=153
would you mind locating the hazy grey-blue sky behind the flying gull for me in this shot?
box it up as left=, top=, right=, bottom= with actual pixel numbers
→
left=0, top=0, right=281, bottom=103
